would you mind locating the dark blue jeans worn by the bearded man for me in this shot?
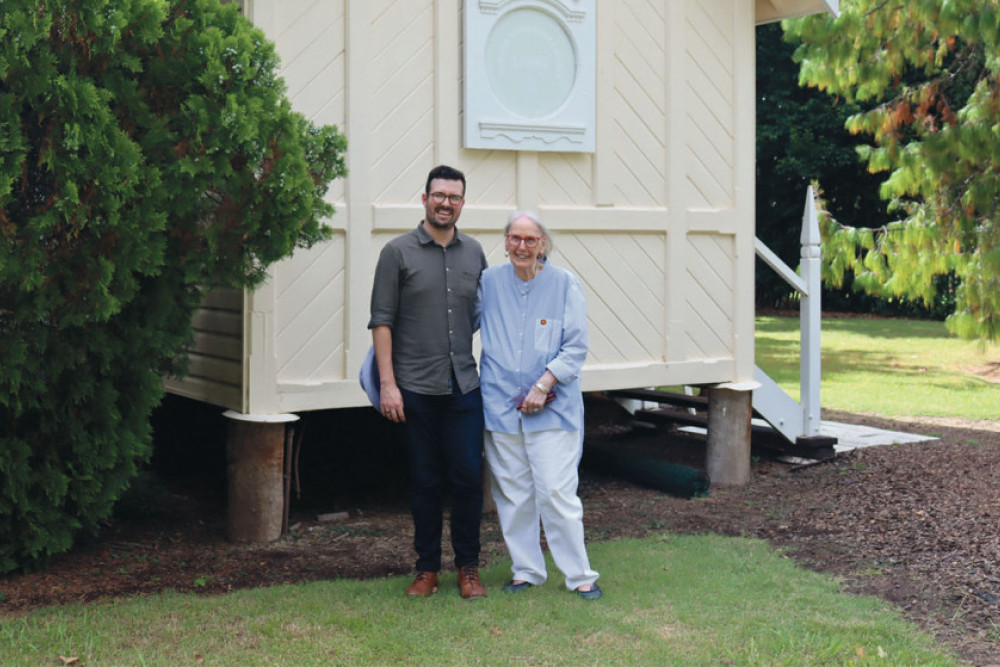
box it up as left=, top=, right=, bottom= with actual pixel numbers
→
left=400, top=381, right=484, bottom=572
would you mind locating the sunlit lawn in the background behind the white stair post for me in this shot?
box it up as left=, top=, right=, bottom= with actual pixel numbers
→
left=755, top=317, right=1000, bottom=419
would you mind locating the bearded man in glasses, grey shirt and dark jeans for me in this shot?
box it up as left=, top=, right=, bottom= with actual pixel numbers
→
left=368, top=165, right=486, bottom=599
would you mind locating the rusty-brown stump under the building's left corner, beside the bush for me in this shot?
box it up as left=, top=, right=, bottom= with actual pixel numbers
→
left=225, top=410, right=298, bottom=543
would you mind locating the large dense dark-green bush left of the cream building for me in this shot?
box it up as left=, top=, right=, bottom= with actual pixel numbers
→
left=0, top=0, right=345, bottom=573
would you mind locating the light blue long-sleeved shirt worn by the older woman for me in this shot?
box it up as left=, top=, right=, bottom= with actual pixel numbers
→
left=479, top=263, right=587, bottom=433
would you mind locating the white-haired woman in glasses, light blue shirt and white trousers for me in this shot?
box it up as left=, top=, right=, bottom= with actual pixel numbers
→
left=479, top=211, right=603, bottom=600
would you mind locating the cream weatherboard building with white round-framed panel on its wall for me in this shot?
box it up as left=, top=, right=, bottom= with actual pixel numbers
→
left=168, top=0, right=837, bottom=516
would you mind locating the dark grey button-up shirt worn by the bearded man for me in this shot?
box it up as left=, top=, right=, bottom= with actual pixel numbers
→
left=368, top=222, right=487, bottom=395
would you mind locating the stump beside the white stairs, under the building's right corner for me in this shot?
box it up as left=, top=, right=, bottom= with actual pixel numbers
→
left=706, top=386, right=753, bottom=486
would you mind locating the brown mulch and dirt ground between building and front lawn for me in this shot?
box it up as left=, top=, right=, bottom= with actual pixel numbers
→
left=0, top=400, right=1000, bottom=665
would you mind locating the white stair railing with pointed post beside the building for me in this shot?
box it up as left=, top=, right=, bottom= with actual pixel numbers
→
left=753, top=186, right=822, bottom=442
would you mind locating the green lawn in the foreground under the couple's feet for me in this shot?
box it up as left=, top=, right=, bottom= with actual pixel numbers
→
left=0, top=536, right=959, bottom=666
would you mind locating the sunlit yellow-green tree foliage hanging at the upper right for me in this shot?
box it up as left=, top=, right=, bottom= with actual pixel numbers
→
left=785, top=0, right=1000, bottom=340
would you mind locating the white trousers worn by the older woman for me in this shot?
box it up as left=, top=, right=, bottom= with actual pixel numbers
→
left=484, top=431, right=598, bottom=590
